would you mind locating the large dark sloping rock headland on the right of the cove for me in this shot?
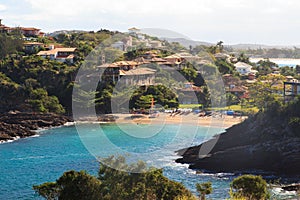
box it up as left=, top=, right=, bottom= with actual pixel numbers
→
left=176, top=113, right=300, bottom=176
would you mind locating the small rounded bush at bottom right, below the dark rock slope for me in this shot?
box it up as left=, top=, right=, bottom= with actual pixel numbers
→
left=230, top=175, right=270, bottom=200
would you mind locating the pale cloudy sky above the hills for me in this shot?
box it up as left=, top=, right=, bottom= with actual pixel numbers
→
left=0, top=0, right=300, bottom=45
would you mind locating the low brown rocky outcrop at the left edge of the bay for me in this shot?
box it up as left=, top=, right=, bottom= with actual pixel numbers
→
left=0, top=112, right=72, bottom=141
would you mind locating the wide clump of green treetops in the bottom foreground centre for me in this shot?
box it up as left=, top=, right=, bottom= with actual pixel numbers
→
left=33, top=156, right=195, bottom=200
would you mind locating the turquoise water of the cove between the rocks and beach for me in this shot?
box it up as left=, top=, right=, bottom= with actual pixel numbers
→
left=0, top=124, right=232, bottom=199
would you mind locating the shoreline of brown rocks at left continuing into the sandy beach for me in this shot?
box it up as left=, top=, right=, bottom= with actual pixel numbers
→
left=0, top=112, right=247, bottom=144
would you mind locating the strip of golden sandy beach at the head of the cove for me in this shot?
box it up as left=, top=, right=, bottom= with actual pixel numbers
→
left=110, top=113, right=247, bottom=128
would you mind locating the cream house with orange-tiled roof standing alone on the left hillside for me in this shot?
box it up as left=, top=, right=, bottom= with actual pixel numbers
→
left=37, top=48, right=76, bottom=63
